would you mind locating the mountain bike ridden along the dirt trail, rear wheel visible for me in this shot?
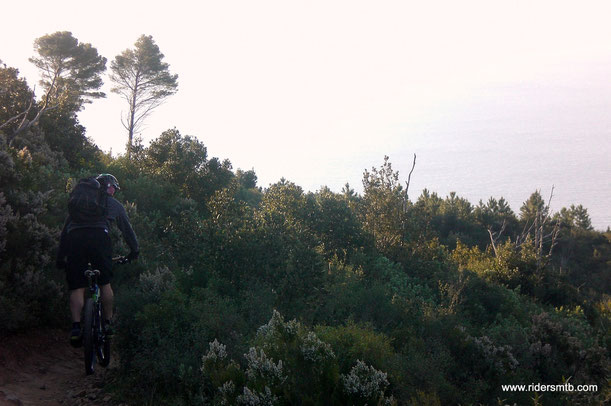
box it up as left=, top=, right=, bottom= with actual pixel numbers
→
left=83, top=257, right=128, bottom=375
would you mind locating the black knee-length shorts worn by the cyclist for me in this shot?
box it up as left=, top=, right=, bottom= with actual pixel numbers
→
left=66, top=228, right=112, bottom=290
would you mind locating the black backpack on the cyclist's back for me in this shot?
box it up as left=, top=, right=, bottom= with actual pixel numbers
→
left=68, top=178, right=108, bottom=224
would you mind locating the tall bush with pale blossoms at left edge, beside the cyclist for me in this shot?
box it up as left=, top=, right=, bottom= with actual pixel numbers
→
left=0, top=106, right=66, bottom=335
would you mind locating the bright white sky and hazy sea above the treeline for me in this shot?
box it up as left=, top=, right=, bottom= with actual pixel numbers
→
left=0, top=0, right=611, bottom=229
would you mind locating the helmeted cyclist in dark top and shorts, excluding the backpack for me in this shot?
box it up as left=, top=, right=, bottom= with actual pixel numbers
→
left=57, top=173, right=139, bottom=347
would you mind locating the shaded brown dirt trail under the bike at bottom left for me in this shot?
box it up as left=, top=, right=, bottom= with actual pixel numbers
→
left=0, top=330, right=125, bottom=406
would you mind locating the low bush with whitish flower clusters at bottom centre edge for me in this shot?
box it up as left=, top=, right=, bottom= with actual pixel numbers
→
left=202, top=311, right=394, bottom=405
